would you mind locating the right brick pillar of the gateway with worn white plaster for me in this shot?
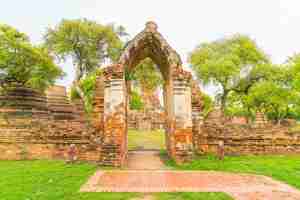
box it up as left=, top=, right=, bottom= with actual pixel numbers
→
left=168, top=68, right=193, bottom=163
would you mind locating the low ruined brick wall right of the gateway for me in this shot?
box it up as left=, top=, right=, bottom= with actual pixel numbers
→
left=195, top=117, right=300, bottom=155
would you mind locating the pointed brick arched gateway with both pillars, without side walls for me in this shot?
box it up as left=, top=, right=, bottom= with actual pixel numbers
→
left=101, top=22, right=198, bottom=166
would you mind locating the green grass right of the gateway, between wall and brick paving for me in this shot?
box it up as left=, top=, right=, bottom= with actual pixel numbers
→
left=166, top=155, right=300, bottom=189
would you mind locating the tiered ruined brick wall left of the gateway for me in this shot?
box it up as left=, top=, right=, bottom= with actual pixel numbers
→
left=0, top=87, right=100, bottom=161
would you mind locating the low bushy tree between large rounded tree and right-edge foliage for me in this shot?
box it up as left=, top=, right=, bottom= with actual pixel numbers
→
left=226, top=64, right=292, bottom=120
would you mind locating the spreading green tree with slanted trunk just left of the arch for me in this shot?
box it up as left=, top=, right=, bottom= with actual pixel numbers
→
left=45, top=19, right=124, bottom=101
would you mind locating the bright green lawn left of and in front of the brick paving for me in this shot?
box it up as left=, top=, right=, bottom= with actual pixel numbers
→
left=0, top=161, right=231, bottom=200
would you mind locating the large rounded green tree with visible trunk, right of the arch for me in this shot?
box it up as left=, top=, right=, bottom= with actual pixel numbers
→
left=190, top=35, right=269, bottom=112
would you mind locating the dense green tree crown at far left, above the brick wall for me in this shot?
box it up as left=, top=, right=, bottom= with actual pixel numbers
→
left=0, top=24, right=63, bottom=90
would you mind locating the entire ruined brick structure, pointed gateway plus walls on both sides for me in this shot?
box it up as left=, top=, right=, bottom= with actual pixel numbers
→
left=0, top=22, right=300, bottom=166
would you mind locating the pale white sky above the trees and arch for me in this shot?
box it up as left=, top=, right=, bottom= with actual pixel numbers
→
left=0, top=0, right=300, bottom=95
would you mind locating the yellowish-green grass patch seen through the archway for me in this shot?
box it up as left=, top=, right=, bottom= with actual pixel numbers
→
left=128, top=130, right=165, bottom=150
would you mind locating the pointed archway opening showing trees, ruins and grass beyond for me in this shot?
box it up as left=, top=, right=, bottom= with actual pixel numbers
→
left=126, top=57, right=166, bottom=151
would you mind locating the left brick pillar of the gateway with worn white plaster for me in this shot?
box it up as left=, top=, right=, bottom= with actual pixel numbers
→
left=100, top=65, right=127, bottom=166
